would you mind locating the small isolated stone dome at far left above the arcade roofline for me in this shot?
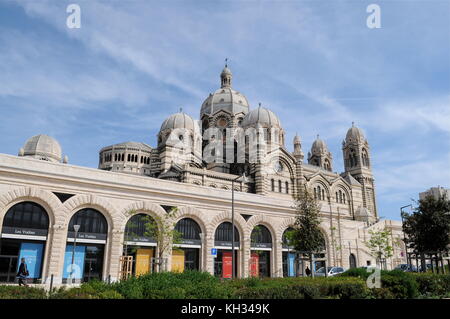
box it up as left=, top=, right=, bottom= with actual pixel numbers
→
left=21, top=134, right=61, bottom=162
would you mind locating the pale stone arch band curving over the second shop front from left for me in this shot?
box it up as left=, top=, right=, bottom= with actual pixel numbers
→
left=58, top=194, right=118, bottom=232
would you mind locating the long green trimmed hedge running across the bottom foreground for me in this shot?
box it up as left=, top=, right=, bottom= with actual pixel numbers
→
left=0, top=269, right=450, bottom=299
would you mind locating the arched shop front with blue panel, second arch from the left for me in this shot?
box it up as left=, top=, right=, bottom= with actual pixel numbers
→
left=63, top=208, right=108, bottom=283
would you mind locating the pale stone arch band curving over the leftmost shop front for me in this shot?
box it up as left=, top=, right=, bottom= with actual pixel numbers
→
left=0, top=187, right=62, bottom=228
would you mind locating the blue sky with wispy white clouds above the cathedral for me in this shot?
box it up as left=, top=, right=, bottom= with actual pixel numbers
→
left=0, top=0, right=450, bottom=220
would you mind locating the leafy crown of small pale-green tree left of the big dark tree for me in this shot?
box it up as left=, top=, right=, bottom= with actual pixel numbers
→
left=364, top=228, right=394, bottom=268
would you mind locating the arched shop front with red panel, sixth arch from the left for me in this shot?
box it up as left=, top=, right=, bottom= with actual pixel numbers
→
left=249, top=225, right=272, bottom=278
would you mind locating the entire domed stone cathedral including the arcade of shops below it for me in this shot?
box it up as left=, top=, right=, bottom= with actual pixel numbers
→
left=0, top=65, right=405, bottom=284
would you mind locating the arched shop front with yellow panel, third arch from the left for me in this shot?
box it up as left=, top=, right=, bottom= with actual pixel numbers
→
left=123, top=214, right=158, bottom=276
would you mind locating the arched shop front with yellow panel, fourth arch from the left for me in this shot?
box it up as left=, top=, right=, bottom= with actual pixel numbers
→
left=172, top=218, right=202, bottom=272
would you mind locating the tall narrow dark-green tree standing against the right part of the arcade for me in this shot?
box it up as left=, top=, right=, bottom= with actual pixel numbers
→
left=290, top=187, right=325, bottom=276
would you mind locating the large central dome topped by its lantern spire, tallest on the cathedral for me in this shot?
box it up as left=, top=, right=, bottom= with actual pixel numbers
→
left=200, top=65, right=249, bottom=119
